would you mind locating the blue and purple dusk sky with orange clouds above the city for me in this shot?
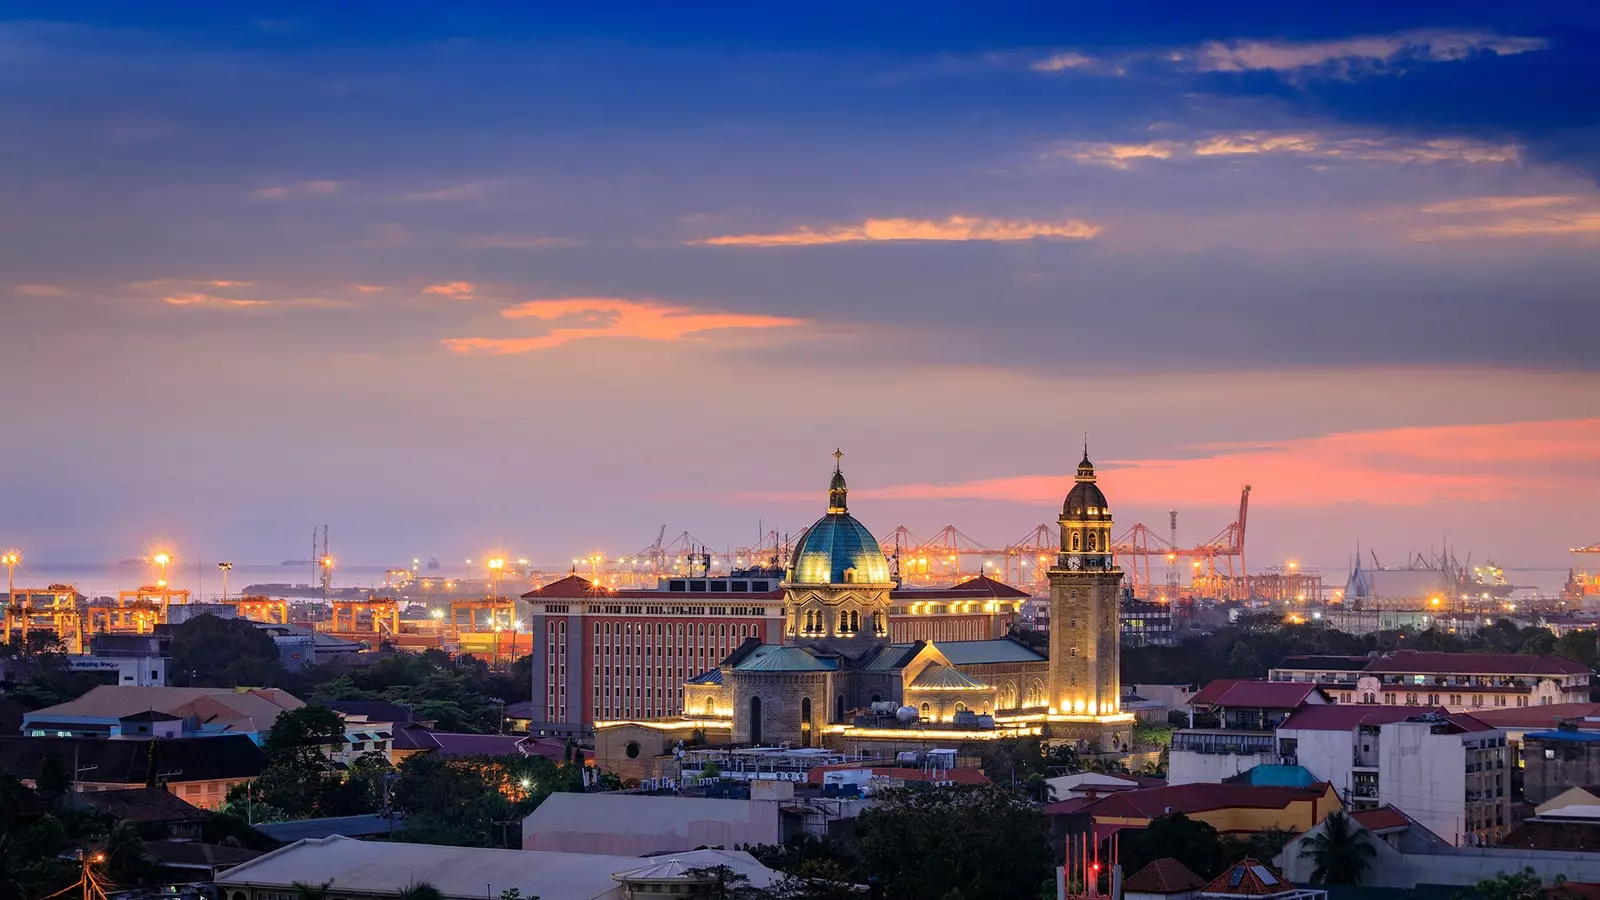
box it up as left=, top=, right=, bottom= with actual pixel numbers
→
left=0, top=0, right=1600, bottom=578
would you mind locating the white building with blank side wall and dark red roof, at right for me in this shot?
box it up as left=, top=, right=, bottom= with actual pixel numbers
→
left=1277, top=706, right=1510, bottom=846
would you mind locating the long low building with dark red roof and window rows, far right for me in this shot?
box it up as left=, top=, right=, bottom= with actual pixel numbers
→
left=1267, top=650, right=1590, bottom=713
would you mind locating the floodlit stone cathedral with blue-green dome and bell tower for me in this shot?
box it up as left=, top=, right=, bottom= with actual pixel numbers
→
left=614, top=450, right=1133, bottom=754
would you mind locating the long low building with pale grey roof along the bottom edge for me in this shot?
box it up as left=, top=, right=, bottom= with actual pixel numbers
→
left=216, top=836, right=781, bottom=900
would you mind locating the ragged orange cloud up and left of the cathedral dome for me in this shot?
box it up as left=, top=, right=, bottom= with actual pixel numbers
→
left=445, top=296, right=803, bottom=354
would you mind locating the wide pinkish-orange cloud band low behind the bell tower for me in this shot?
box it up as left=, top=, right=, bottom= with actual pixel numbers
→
left=745, top=418, right=1600, bottom=516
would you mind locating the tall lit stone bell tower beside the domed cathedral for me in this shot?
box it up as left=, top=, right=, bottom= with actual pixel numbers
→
left=1046, top=445, right=1122, bottom=719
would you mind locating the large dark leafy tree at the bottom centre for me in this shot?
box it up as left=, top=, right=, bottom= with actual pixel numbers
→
left=856, top=785, right=1051, bottom=900
